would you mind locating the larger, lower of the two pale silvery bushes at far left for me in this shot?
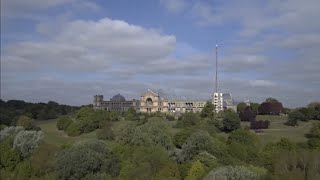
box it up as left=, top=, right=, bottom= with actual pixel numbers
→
left=13, top=131, right=43, bottom=158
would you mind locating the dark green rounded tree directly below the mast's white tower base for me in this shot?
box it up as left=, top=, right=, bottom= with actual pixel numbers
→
left=222, top=111, right=240, bottom=132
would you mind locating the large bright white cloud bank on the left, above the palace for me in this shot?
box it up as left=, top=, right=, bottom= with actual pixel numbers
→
left=1, top=18, right=176, bottom=72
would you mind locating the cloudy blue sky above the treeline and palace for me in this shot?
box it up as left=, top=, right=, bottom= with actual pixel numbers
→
left=1, top=0, right=320, bottom=107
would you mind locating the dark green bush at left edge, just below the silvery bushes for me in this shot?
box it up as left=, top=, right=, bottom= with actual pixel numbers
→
left=0, top=138, right=21, bottom=171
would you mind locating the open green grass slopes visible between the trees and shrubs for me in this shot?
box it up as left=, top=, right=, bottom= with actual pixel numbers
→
left=37, top=115, right=315, bottom=146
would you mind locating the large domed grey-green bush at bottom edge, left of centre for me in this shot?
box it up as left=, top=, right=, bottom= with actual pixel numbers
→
left=56, top=141, right=120, bottom=179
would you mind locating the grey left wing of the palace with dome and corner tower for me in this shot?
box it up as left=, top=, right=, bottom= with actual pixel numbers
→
left=93, top=94, right=139, bottom=112
